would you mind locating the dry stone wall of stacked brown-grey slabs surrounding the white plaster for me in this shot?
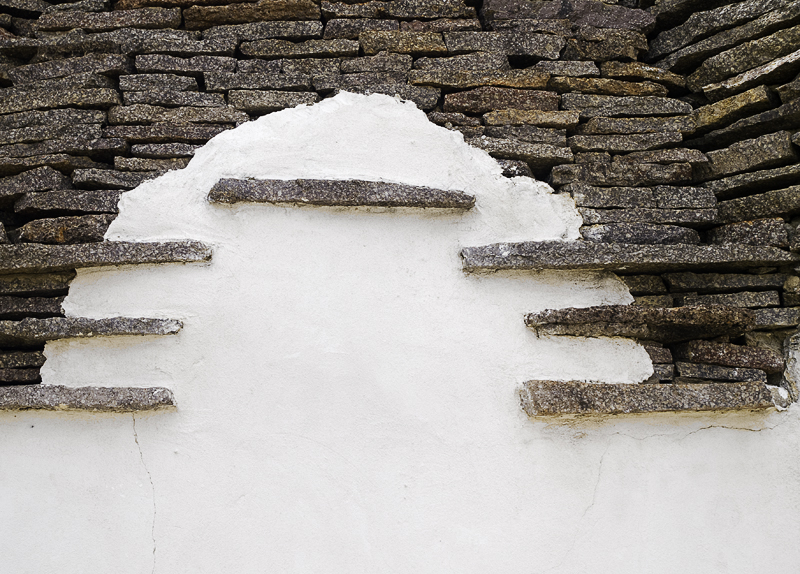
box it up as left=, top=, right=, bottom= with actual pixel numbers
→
left=0, top=0, right=800, bottom=410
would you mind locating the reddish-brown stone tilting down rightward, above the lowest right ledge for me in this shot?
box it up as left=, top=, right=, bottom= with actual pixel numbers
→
left=673, top=341, right=785, bottom=374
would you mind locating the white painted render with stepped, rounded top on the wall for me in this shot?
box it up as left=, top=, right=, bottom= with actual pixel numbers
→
left=0, top=94, right=800, bottom=574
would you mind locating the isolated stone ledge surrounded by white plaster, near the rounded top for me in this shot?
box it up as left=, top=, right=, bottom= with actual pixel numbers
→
left=208, top=179, right=475, bottom=209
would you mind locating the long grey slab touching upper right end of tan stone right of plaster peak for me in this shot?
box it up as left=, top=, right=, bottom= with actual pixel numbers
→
left=561, top=94, right=692, bottom=119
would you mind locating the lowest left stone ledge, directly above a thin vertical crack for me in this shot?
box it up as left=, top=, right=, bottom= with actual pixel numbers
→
left=0, top=385, right=175, bottom=413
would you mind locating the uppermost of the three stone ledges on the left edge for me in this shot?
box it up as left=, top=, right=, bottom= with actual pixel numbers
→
left=0, top=241, right=211, bottom=275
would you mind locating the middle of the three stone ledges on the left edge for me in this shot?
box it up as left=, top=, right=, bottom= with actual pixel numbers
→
left=0, top=317, right=183, bottom=346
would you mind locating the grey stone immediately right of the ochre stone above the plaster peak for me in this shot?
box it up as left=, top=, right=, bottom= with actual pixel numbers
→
left=443, top=32, right=565, bottom=60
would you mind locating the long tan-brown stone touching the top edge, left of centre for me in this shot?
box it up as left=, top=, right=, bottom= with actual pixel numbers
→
left=183, top=0, right=320, bottom=30
